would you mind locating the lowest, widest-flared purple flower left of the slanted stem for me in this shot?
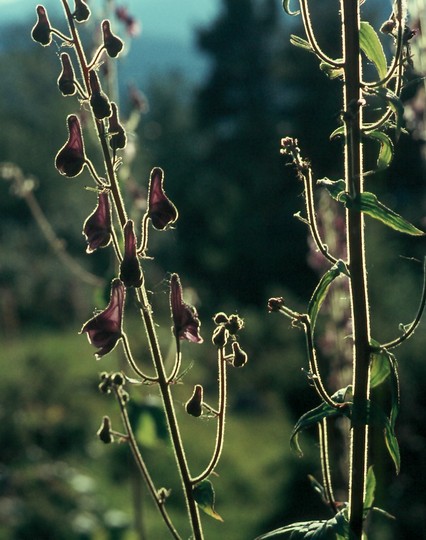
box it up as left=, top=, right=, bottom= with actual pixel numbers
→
left=80, top=279, right=126, bottom=360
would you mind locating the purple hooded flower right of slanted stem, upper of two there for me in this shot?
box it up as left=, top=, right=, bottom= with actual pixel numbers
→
left=148, top=167, right=178, bottom=231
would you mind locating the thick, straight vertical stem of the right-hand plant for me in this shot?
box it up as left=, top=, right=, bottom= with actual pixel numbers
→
left=341, top=0, right=370, bottom=539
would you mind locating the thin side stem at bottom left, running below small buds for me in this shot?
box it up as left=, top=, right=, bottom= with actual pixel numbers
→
left=114, top=388, right=181, bottom=540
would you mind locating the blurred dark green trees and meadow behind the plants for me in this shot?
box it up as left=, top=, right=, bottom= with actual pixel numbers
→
left=0, top=0, right=426, bottom=540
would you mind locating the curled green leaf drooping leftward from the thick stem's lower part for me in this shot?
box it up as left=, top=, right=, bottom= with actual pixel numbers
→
left=290, top=386, right=352, bottom=457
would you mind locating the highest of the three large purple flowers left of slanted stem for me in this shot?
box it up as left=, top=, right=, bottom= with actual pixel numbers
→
left=55, top=114, right=86, bottom=178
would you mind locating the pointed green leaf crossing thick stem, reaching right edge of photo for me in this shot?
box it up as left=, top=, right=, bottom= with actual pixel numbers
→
left=348, top=192, right=426, bottom=236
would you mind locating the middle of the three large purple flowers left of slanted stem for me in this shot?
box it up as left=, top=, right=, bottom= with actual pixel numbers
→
left=83, top=191, right=112, bottom=253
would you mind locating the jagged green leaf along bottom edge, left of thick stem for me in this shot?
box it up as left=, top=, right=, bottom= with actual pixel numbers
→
left=255, top=510, right=354, bottom=540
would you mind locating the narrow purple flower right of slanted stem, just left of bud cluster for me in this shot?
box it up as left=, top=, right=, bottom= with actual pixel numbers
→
left=170, top=274, right=203, bottom=343
